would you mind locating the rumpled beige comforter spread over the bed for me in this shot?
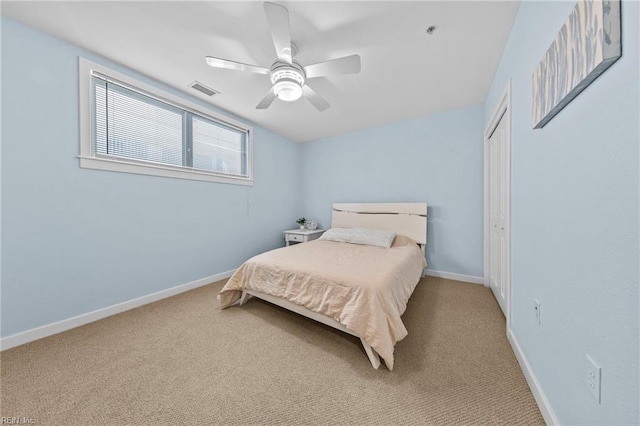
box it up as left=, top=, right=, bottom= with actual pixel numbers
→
left=218, top=236, right=426, bottom=370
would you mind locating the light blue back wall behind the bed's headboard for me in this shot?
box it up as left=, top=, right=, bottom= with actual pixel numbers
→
left=303, top=106, right=484, bottom=277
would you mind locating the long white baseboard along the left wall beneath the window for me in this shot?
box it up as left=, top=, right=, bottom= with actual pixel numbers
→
left=0, top=269, right=235, bottom=350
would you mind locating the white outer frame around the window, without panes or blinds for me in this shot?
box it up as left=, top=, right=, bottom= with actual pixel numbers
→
left=78, top=57, right=253, bottom=185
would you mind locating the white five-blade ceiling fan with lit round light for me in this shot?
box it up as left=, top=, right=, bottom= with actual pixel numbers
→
left=206, top=2, right=360, bottom=111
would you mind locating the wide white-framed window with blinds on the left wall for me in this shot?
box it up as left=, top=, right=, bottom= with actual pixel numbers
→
left=80, top=58, right=253, bottom=185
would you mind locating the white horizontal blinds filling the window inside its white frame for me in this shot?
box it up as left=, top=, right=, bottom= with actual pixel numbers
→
left=92, top=74, right=248, bottom=177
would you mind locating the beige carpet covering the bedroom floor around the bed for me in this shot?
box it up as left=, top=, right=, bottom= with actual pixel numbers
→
left=1, top=277, right=543, bottom=425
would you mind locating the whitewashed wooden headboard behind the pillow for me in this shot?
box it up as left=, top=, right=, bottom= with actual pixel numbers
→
left=331, top=203, right=427, bottom=246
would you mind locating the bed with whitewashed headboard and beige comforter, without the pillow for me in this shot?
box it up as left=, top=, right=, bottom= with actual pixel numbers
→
left=218, top=203, right=427, bottom=370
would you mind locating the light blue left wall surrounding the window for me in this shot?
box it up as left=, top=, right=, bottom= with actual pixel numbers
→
left=1, top=17, right=302, bottom=337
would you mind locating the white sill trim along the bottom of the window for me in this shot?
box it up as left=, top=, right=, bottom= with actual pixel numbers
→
left=78, top=156, right=253, bottom=186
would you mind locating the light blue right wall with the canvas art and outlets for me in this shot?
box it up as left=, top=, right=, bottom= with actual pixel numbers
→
left=485, top=2, right=640, bottom=424
